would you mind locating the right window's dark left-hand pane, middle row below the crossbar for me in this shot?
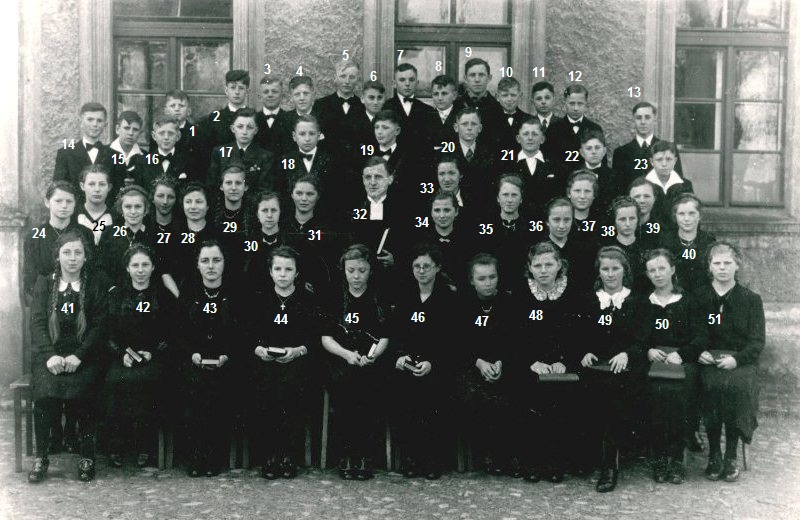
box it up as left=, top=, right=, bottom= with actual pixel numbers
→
left=675, top=103, right=722, bottom=150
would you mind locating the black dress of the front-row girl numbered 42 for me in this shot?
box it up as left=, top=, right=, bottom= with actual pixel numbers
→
left=103, top=280, right=178, bottom=453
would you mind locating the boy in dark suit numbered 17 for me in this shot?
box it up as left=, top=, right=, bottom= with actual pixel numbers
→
left=206, top=108, right=277, bottom=193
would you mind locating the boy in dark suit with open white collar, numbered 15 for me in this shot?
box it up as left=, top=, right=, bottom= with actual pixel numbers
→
left=108, top=110, right=144, bottom=202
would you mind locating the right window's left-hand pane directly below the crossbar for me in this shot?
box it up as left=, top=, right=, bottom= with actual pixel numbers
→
left=675, top=48, right=722, bottom=99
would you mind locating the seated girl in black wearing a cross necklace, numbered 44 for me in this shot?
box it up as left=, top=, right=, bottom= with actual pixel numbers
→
left=248, top=246, right=321, bottom=479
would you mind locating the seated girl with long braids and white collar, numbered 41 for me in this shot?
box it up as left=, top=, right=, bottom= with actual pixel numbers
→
left=28, top=230, right=108, bottom=483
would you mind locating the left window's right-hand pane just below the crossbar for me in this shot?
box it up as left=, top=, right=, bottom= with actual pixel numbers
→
left=181, top=40, right=231, bottom=92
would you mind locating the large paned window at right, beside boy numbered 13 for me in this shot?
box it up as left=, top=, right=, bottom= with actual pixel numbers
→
left=675, top=0, right=789, bottom=207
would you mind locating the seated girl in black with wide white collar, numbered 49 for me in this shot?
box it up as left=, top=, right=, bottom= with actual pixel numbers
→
left=581, top=246, right=645, bottom=493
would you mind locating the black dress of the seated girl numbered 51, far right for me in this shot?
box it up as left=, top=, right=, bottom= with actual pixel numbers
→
left=697, top=283, right=765, bottom=443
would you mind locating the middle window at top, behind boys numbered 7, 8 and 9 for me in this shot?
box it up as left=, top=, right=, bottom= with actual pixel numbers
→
left=395, top=0, right=513, bottom=98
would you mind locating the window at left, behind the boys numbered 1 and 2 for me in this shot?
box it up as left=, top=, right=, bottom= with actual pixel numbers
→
left=113, top=0, right=233, bottom=145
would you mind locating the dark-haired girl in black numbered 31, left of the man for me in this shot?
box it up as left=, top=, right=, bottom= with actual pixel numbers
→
left=283, top=175, right=336, bottom=297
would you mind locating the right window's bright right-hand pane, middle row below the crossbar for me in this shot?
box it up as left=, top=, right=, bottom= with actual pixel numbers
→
left=733, top=103, right=781, bottom=151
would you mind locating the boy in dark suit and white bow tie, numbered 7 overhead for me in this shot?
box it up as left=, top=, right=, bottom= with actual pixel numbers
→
left=384, top=63, right=433, bottom=152
